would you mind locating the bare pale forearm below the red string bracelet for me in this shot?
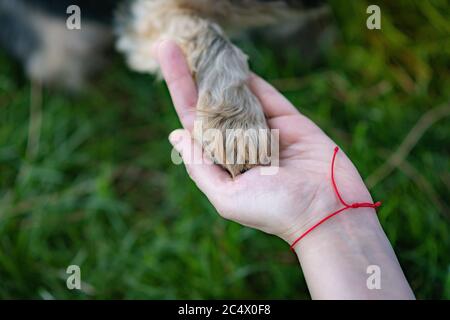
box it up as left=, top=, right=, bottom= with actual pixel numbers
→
left=295, top=208, right=414, bottom=299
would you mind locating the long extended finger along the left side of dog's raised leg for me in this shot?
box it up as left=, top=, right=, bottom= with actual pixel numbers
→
left=154, top=40, right=197, bottom=131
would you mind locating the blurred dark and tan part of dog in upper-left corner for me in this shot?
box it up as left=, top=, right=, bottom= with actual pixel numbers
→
left=0, top=0, right=118, bottom=90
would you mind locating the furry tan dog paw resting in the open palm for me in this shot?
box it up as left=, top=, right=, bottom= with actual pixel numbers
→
left=194, top=84, right=270, bottom=177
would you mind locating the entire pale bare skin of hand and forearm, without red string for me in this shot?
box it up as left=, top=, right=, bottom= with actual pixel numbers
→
left=153, top=40, right=414, bottom=299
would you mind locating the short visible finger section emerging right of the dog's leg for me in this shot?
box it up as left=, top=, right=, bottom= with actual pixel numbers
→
left=249, top=73, right=299, bottom=119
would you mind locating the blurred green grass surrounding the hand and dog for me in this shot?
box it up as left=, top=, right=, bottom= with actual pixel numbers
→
left=0, top=0, right=450, bottom=299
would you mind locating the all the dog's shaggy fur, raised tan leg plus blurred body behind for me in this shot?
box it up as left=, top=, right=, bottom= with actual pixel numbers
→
left=0, top=0, right=324, bottom=176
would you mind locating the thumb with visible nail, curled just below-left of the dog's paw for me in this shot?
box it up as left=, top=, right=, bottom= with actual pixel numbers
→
left=169, top=129, right=231, bottom=198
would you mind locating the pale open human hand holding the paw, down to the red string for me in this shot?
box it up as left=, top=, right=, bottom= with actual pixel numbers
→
left=154, top=40, right=372, bottom=244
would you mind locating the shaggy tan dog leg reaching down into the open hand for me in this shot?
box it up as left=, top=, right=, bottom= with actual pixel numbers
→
left=118, top=0, right=270, bottom=177
